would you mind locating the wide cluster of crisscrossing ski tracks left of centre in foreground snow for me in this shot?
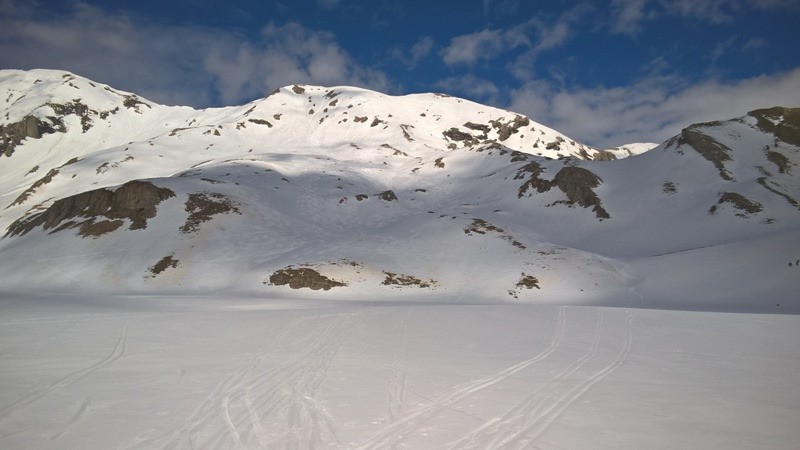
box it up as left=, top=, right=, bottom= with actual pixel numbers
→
left=137, top=314, right=361, bottom=449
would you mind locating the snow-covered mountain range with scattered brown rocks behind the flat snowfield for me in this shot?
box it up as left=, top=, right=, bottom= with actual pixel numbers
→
left=0, top=70, right=800, bottom=310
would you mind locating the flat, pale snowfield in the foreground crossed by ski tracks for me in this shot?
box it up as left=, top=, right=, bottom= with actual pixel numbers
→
left=0, top=295, right=800, bottom=449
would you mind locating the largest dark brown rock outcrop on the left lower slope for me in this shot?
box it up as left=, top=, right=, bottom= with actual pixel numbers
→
left=6, top=181, right=175, bottom=236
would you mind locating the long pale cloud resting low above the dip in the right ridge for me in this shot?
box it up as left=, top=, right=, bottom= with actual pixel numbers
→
left=508, top=69, right=800, bottom=147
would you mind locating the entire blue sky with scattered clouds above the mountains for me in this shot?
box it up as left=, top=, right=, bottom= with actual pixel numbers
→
left=0, top=0, right=800, bottom=147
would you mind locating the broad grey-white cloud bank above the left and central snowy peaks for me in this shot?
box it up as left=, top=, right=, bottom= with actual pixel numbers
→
left=0, top=1, right=391, bottom=106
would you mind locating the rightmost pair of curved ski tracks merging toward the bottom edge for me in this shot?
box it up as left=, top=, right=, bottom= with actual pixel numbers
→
left=449, top=308, right=634, bottom=449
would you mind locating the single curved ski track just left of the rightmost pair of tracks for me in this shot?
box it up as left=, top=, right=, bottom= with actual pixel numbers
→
left=356, top=306, right=566, bottom=449
